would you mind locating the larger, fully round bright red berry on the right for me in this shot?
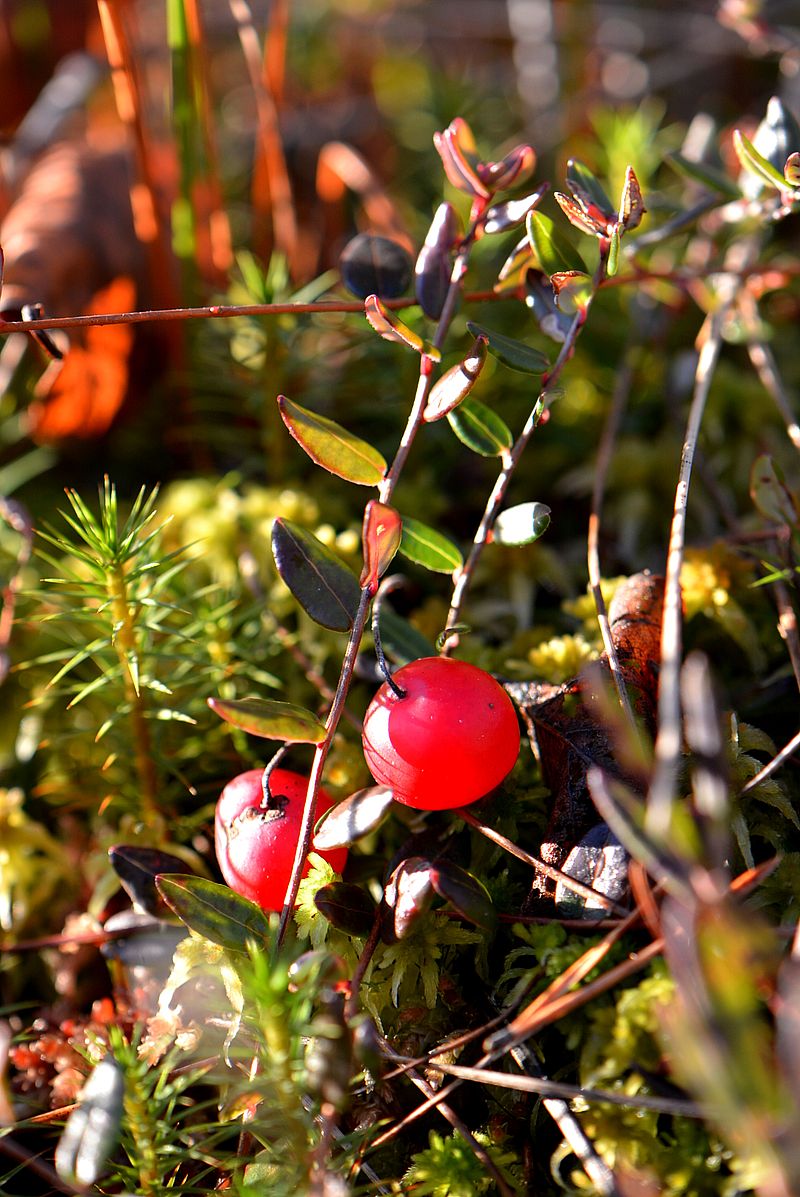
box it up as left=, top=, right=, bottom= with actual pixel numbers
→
left=363, top=657, right=520, bottom=810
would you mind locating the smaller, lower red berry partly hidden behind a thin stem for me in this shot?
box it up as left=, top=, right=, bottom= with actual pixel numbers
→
left=214, top=768, right=347, bottom=911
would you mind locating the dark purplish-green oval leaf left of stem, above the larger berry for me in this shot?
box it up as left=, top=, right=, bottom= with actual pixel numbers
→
left=272, top=519, right=360, bottom=632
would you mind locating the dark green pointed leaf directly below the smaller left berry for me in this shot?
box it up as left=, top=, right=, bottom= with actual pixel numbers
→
left=156, top=873, right=273, bottom=952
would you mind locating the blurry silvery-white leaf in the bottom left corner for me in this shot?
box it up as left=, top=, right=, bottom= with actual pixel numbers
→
left=54, top=1051, right=125, bottom=1192
